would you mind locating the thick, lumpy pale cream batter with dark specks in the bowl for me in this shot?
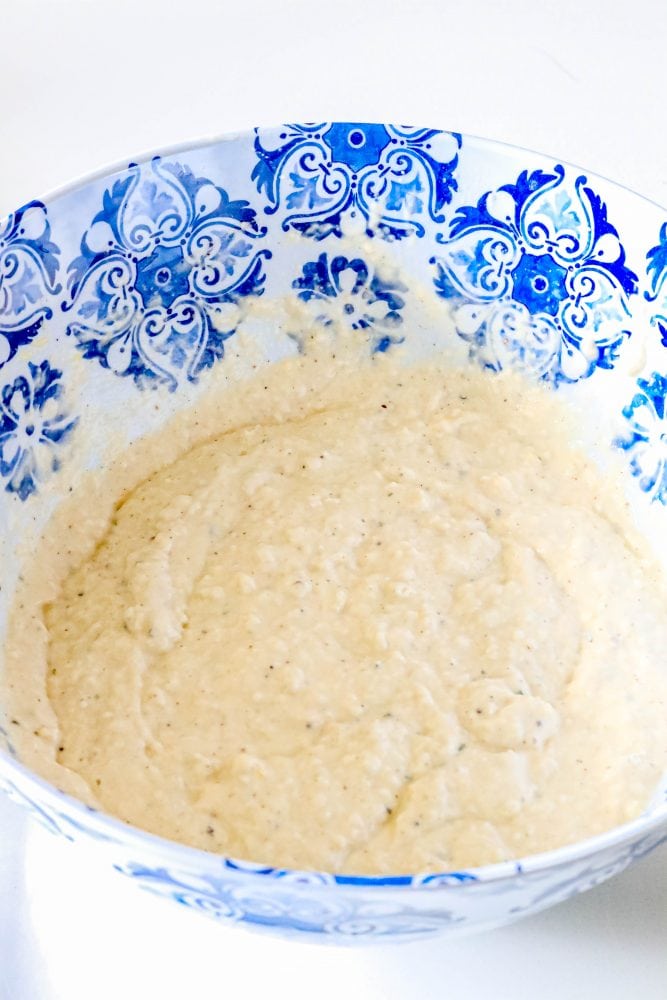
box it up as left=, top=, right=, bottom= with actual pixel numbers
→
left=7, top=361, right=667, bottom=872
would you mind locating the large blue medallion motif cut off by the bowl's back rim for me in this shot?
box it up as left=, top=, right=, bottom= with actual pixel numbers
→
left=252, top=122, right=461, bottom=239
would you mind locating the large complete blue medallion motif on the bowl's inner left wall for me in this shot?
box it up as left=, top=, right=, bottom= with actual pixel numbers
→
left=63, top=157, right=271, bottom=390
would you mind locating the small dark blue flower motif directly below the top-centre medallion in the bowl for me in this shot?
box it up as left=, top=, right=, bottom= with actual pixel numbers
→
left=292, top=253, right=407, bottom=351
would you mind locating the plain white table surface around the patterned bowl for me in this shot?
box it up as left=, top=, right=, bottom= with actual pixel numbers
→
left=0, top=0, right=667, bottom=1000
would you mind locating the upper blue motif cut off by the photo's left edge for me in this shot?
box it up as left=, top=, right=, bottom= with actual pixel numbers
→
left=0, top=201, right=61, bottom=368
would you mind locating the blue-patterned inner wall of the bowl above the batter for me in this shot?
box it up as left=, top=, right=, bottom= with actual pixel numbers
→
left=0, top=123, right=667, bottom=828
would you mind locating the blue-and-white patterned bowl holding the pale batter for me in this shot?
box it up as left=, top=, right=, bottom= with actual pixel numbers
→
left=0, top=122, right=667, bottom=942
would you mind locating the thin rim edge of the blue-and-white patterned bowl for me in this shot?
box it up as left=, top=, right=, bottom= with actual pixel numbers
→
left=0, top=119, right=667, bottom=891
